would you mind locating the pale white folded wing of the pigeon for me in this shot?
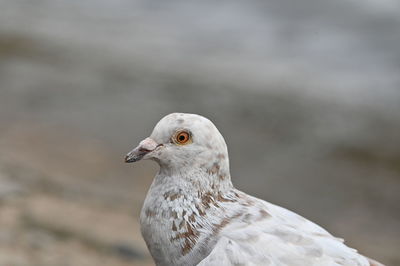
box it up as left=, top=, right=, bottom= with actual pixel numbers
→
left=199, top=201, right=370, bottom=266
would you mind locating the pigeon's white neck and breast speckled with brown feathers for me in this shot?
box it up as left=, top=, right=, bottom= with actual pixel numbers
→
left=141, top=168, right=237, bottom=265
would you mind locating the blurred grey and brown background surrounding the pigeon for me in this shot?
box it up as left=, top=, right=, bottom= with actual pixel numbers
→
left=0, top=0, right=400, bottom=266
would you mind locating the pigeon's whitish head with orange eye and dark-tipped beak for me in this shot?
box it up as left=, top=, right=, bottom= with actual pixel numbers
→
left=125, top=113, right=230, bottom=179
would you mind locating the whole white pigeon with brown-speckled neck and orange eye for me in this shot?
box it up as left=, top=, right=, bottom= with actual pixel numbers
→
left=125, top=113, right=382, bottom=266
